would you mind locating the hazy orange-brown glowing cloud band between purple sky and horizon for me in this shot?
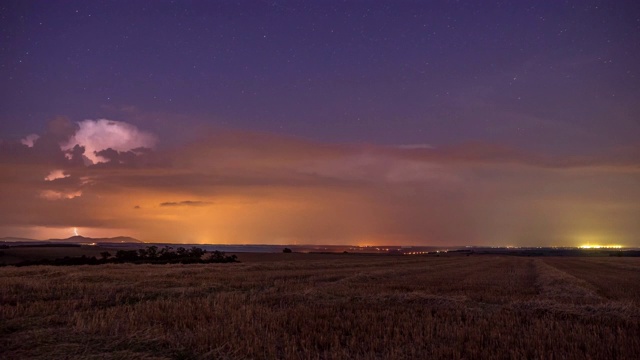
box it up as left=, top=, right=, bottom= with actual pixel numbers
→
left=0, top=121, right=640, bottom=246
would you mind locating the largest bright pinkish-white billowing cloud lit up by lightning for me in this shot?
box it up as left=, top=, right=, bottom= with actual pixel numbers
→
left=62, top=119, right=157, bottom=164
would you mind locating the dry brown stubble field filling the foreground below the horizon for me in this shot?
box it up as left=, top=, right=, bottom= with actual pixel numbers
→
left=0, top=254, right=640, bottom=359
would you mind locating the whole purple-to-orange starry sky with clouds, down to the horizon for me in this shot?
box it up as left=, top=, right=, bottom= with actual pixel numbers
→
left=0, top=0, right=640, bottom=246
